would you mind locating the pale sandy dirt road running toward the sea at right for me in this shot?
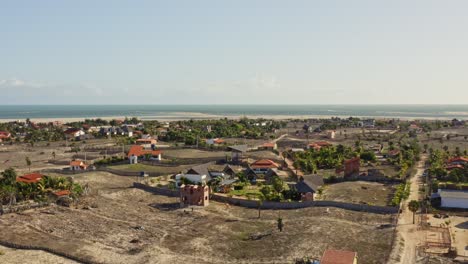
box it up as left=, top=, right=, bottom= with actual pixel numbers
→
left=391, top=155, right=427, bottom=264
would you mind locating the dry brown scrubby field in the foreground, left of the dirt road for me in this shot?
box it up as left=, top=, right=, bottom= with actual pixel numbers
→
left=0, top=173, right=392, bottom=263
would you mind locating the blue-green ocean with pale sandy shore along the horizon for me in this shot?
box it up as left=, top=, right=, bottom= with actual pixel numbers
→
left=0, top=105, right=468, bottom=120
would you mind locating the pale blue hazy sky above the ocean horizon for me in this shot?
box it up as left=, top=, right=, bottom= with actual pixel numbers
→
left=0, top=0, right=468, bottom=104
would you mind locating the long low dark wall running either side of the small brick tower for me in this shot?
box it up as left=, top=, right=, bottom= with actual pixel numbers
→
left=133, top=182, right=398, bottom=214
